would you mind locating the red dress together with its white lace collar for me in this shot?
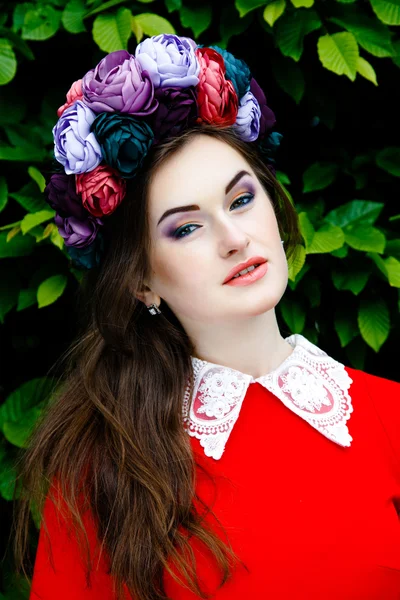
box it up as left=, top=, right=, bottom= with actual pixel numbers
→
left=30, top=335, right=400, bottom=600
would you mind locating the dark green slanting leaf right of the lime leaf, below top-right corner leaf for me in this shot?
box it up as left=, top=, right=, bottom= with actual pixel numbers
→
left=329, top=9, right=395, bottom=58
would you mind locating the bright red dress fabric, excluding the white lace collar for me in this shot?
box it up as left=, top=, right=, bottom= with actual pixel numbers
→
left=30, top=367, right=400, bottom=600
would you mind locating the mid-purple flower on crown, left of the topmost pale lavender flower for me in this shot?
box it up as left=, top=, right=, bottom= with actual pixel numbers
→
left=82, top=50, right=158, bottom=116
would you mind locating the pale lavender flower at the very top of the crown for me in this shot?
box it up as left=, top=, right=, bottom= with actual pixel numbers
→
left=135, top=33, right=200, bottom=88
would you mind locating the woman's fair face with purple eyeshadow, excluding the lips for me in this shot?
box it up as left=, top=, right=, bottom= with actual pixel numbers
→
left=146, top=135, right=288, bottom=327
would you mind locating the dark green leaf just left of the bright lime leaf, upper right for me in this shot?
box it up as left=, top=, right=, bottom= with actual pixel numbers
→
left=276, top=8, right=321, bottom=62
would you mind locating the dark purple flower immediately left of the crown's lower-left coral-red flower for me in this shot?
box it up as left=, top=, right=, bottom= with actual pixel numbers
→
left=44, top=173, right=87, bottom=220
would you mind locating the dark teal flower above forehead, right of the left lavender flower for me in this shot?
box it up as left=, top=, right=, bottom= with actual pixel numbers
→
left=92, top=112, right=154, bottom=179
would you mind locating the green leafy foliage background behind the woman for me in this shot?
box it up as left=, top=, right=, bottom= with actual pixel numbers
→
left=0, top=0, right=400, bottom=600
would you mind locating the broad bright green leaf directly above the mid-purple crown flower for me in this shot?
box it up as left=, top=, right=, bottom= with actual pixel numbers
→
left=92, top=8, right=136, bottom=52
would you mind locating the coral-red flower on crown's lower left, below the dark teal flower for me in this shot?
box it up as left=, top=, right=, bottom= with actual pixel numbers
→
left=76, top=165, right=126, bottom=217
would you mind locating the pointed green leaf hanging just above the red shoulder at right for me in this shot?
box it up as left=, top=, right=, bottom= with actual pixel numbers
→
left=358, top=297, right=390, bottom=352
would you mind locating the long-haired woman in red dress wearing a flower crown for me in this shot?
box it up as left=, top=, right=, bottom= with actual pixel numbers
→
left=15, top=35, right=400, bottom=600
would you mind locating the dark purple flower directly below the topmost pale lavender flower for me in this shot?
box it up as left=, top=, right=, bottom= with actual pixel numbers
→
left=150, top=87, right=197, bottom=144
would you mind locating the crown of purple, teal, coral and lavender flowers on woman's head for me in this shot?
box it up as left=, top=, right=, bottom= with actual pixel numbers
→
left=45, top=34, right=282, bottom=269
